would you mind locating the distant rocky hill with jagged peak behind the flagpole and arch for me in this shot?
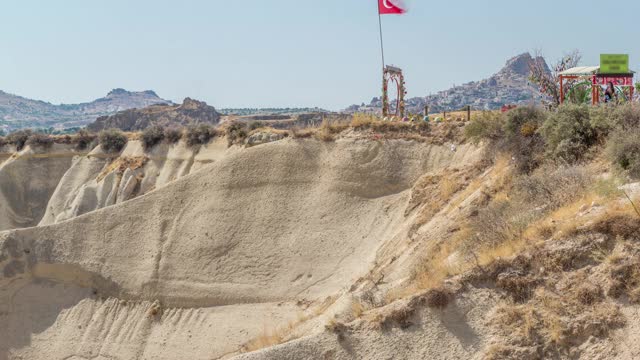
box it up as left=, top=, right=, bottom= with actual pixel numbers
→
left=347, top=53, right=546, bottom=113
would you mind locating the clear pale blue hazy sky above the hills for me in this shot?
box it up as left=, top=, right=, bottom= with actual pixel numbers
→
left=0, top=0, right=640, bottom=110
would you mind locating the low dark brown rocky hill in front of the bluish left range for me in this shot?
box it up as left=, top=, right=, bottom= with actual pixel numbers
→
left=87, top=98, right=220, bottom=131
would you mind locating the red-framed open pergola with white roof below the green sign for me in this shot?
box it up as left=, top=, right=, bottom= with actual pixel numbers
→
left=559, top=66, right=635, bottom=105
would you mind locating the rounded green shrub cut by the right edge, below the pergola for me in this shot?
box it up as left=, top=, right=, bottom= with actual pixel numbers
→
left=606, top=127, right=640, bottom=179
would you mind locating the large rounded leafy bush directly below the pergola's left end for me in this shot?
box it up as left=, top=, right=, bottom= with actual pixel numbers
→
left=540, top=105, right=598, bottom=163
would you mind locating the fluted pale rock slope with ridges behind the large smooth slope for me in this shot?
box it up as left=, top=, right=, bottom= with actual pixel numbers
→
left=39, top=139, right=234, bottom=225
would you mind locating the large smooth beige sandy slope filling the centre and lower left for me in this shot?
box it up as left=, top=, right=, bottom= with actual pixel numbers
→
left=0, top=139, right=480, bottom=359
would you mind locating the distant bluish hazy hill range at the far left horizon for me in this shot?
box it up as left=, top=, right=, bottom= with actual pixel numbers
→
left=0, top=89, right=171, bottom=132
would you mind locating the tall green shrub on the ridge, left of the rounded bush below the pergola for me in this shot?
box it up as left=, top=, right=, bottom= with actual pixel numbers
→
left=500, top=106, right=546, bottom=173
